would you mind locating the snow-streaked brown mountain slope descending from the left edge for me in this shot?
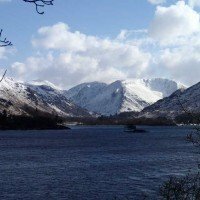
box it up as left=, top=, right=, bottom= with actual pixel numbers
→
left=0, top=78, right=89, bottom=116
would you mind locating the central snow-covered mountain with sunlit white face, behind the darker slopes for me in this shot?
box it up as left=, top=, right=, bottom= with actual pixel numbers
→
left=65, top=79, right=183, bottom=116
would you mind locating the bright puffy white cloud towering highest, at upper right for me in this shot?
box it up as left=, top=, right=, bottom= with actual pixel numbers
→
left=149, top=1, right=200, bottom=43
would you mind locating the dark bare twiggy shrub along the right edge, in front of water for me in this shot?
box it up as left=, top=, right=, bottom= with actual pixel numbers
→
left=160, top=97, right=200, bottom=200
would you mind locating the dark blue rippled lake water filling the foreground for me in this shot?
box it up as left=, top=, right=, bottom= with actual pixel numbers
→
left=0, top=126, right=198, bottom=200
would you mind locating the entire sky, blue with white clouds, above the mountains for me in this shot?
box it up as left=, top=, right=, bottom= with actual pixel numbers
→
left=0, top=0, right=200, bottom=89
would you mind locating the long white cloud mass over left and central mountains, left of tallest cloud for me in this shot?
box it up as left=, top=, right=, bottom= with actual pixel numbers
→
left=12, top=23, right=151, bottom=88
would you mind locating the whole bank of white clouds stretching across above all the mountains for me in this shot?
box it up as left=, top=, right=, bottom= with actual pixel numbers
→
left=7, top=1, right=200, bottom=88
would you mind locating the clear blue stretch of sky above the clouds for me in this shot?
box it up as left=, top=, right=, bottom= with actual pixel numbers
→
left=0, top=0, right=155, bottom=54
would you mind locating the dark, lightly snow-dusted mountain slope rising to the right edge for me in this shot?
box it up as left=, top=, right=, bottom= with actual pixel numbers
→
left=140, top=82, right=200, bottom=118
